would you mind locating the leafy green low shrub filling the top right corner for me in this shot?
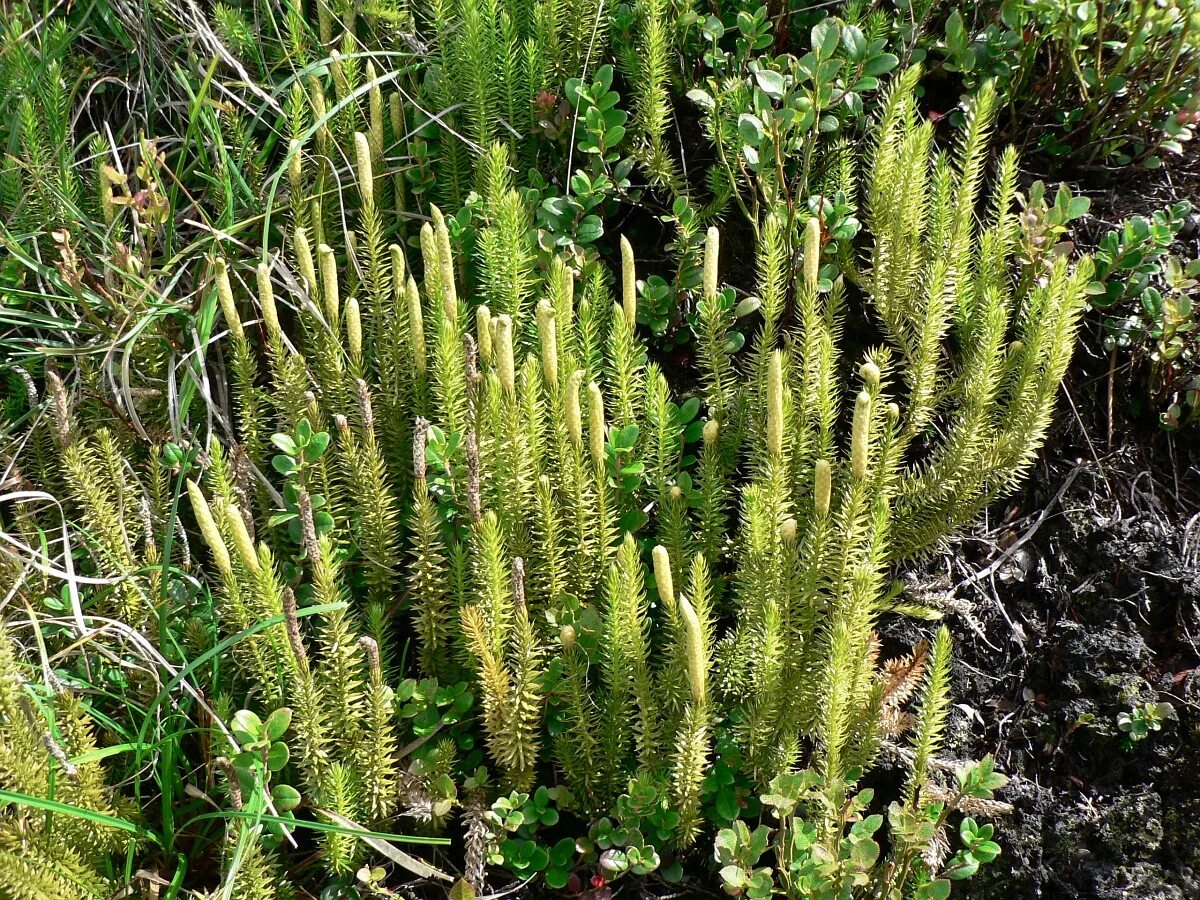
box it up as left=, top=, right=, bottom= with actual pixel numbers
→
left=928, top=0, right=1200, bottom=168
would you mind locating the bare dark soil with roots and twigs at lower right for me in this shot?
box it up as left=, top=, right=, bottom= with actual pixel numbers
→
left=893, top=434, right=1200, bottom=900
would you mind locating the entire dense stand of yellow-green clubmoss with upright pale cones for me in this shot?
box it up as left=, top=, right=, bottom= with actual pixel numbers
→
left=5, top=0, right=1091, bottom=898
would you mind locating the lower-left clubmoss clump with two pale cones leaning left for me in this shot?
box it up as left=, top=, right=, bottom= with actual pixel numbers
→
left=182, top=458, right=417, bottom=874
